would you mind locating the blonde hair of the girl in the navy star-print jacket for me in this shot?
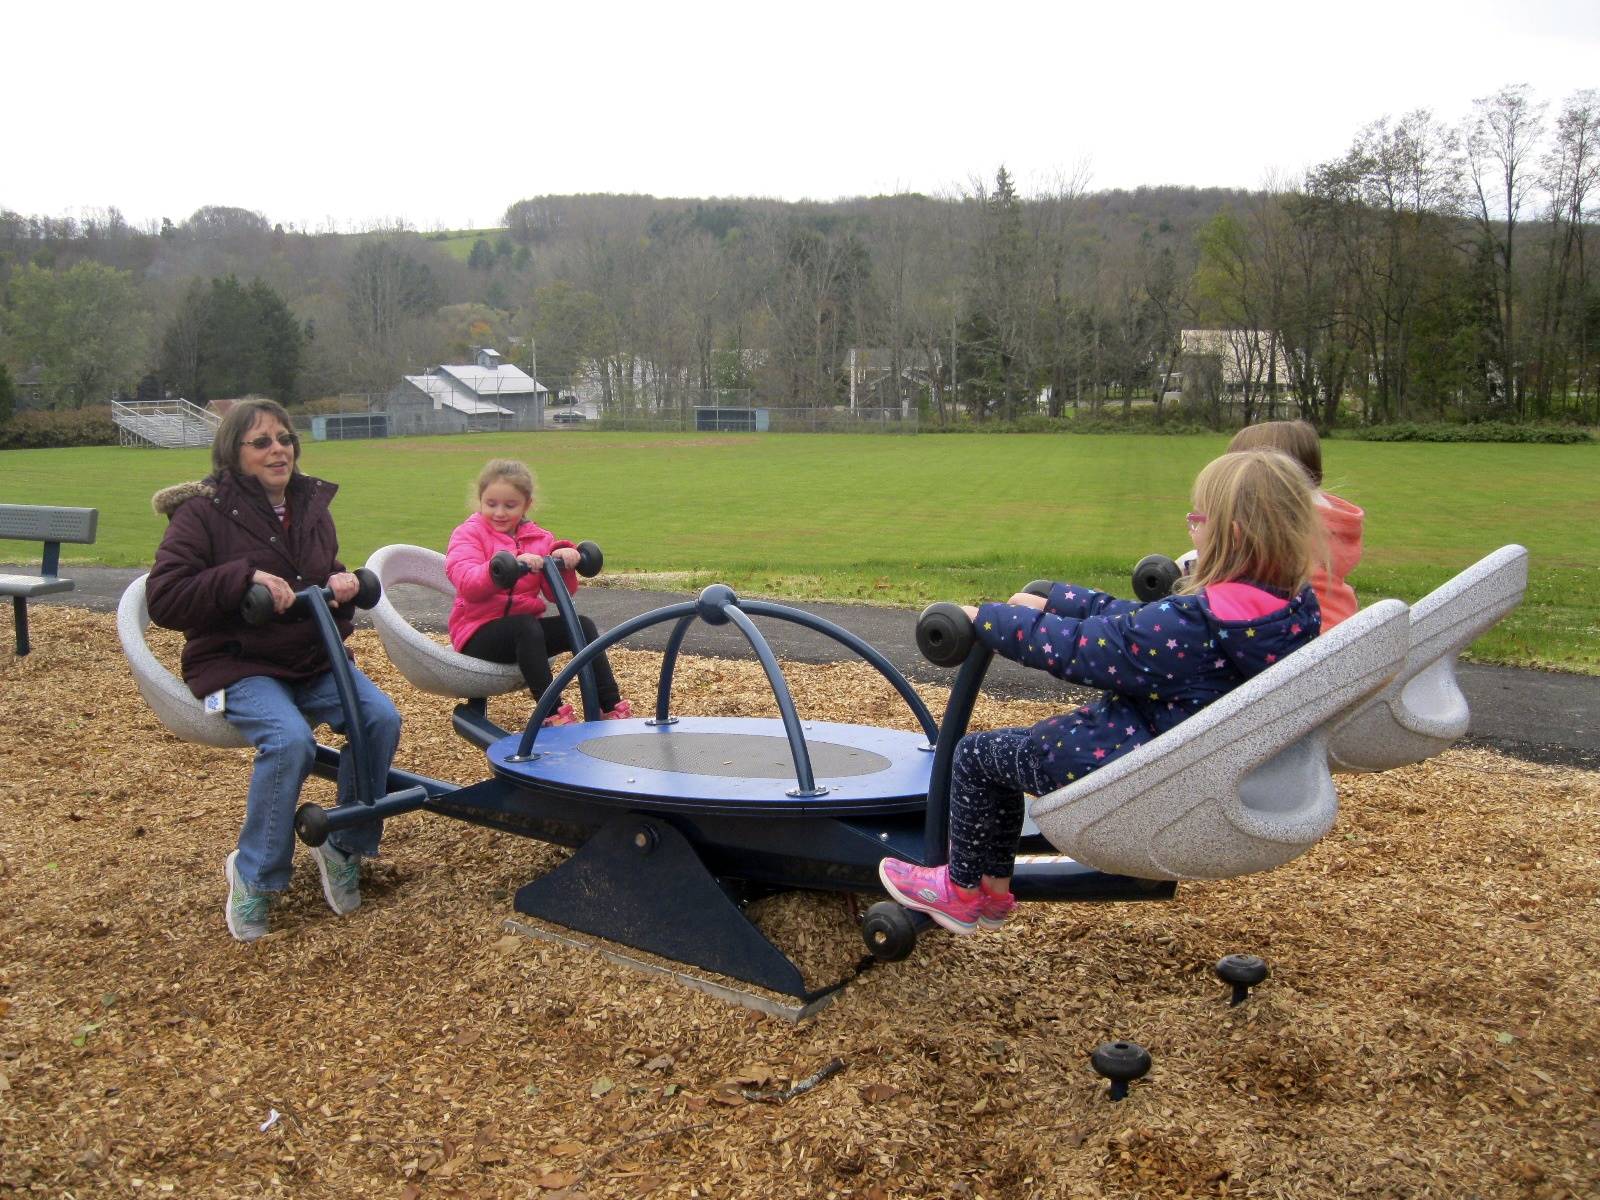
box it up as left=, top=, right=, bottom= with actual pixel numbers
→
left=1178, top=450, right=1323, bottom=595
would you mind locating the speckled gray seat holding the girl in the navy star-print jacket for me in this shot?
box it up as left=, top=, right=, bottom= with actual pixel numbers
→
left=1032, top=600, right=1410, bottom=880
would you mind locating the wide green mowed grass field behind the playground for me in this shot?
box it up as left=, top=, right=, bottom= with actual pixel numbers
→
left=0, top=432, right=1600, bottom=674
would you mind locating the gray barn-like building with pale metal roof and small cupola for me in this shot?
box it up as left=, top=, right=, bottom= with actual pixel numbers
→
left=384, top=347, right=549, bottom=434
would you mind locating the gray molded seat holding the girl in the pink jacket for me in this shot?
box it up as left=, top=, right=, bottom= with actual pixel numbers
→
left=366, top=546, right=526, bottom=699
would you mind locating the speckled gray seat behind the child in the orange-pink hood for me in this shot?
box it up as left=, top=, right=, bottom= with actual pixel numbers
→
left=1328, top=546, right=1528, bottom=771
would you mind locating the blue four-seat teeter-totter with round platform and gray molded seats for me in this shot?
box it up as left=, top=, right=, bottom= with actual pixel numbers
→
left=118, top=546, right=1526, bottom=1008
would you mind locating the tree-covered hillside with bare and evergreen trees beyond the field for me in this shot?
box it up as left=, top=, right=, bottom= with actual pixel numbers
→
left=0, top=88, right=1600, bottom=426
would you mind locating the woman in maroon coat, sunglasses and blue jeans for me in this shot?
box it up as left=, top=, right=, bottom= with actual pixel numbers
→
left=146, top=400, right=400, bottom=941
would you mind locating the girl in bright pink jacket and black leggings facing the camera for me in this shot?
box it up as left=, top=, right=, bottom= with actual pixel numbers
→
left=445, top=458, right=634, bottom=725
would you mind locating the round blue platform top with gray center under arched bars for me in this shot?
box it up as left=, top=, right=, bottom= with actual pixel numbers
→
left=488, top=717, right=933, bottom=816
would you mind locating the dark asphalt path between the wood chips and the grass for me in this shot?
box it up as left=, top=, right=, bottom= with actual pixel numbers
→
left=28, top=563, right=1600, bottom=770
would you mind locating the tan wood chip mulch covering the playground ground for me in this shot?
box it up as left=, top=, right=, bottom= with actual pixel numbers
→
left=0, top=606, right=1600, bottom=1200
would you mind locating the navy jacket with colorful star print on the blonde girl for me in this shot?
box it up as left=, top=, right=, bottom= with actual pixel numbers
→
left=974, top=584, right=1322, bottom=787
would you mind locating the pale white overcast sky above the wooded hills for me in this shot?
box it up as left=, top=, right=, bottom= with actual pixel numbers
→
left=0, top=0, right=1600, bottom=230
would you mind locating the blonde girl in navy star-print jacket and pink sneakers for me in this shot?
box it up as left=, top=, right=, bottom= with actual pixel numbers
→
left=878, top=450, right=1322, bottom=933
